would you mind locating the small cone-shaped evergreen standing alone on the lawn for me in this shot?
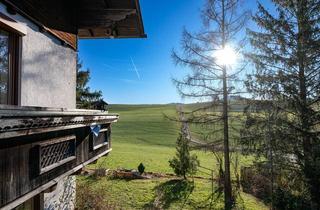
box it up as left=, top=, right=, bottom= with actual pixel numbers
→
left=169, top=124, right=199, bottom=179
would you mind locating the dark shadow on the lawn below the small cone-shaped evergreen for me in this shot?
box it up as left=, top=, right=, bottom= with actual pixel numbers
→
left=144, top=179, right=194, bottom=209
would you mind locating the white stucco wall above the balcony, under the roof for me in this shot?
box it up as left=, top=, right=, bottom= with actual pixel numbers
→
left=0, top=3, right=77, bottom=108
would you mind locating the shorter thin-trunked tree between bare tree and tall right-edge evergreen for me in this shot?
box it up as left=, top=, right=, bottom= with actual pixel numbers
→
left=240, top=100, right=288, bottom=209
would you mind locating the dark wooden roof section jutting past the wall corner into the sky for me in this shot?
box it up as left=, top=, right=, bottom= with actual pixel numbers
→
left=78, top=0, right=146, bottom=38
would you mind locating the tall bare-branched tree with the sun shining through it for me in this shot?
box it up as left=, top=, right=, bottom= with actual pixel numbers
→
left=172, top=0, right=248, bottom=209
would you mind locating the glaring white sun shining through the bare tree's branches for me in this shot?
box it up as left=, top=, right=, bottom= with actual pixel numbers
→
left=214, top=46, right=237, bottom=65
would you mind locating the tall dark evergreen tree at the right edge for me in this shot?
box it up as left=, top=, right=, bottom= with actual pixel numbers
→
left=247, top=0, right=320, bottom=209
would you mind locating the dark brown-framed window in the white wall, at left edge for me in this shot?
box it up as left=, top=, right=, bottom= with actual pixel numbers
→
left=0, top=29, right=20, bottom=105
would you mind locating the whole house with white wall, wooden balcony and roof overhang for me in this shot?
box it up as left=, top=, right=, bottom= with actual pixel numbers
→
left=0, top=0, right=145, bottom=209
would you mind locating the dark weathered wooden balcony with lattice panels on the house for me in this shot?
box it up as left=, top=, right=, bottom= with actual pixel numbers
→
left=0, top=105, right=119, bottom=209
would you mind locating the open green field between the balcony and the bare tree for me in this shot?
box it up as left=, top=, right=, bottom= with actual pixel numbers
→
left=99, top=105, right=178, bottom=172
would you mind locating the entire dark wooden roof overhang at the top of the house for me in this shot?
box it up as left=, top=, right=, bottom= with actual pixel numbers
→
left=3, top=0, right=146, bottom=49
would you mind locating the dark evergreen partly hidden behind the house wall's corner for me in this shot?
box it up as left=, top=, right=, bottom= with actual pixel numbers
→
left=76, top=60, right=102, bottom=109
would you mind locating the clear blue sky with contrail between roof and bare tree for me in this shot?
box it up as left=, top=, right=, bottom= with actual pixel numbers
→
left=79, top=0, right=272, bottom=104
